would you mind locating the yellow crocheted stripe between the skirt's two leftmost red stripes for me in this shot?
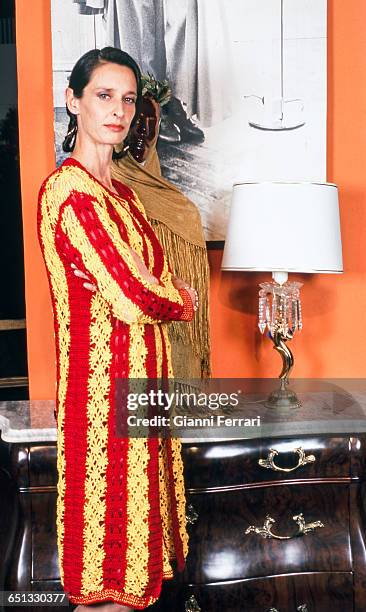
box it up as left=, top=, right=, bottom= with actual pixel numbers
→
left=81, top=293, right=112, bottom=595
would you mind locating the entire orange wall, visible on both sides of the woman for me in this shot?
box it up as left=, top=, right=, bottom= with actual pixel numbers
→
left=16, top=0, right=366, bottom=398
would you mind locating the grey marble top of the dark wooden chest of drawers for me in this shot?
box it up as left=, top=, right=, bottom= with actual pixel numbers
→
left=0, top=379, right=366, bottom=443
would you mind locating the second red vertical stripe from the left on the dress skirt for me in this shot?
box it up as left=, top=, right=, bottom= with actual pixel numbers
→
left=103, top=319, right=130, bottom=591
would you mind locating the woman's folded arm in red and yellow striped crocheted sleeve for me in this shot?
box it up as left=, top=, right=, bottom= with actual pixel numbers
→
left=60, top=194, right=198, bottom=323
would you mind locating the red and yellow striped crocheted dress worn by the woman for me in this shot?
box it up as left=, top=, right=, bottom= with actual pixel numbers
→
left=38, top=159, right=193, bottom=609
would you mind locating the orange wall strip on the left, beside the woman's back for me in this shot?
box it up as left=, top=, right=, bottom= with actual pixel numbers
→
left=15, top=0, right=55, bottom=399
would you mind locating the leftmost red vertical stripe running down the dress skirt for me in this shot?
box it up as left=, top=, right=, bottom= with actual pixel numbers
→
left=56, top=233, right=93, bottom=593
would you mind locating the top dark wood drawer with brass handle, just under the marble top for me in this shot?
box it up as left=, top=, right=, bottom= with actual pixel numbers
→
left=183, top=437, right=350, bottom=490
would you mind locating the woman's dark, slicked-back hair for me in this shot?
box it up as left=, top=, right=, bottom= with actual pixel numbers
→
left=62, top=47, right=142, bottom=159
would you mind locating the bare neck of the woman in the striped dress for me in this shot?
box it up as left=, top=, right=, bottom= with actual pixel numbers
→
left=71, top=143, right=115, bottom=191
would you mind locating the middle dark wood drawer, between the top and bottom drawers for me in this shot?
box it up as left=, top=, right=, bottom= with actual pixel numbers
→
left=185, top=484, right=352, bottom=584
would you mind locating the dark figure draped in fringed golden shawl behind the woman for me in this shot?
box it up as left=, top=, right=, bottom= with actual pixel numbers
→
left=112, top=89, right=211, bottom=379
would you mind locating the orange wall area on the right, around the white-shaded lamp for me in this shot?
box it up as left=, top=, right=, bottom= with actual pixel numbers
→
left=206, top=0, right=366, bottom=377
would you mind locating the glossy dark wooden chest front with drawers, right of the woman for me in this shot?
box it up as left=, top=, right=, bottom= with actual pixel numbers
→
left=177, top=436, right=366, bottom=612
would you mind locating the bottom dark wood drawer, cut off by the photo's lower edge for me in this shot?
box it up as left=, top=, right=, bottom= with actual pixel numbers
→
left=182, top=573, right=354, bottom=612
